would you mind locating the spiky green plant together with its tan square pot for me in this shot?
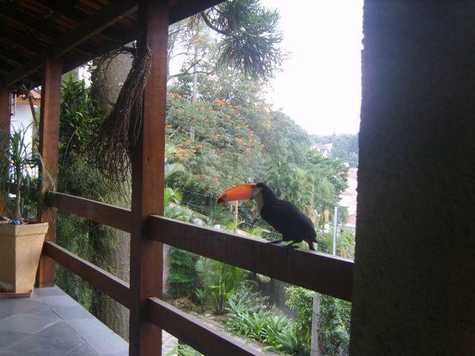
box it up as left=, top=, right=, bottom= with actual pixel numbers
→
left=0, top=127, right=48, bottom=297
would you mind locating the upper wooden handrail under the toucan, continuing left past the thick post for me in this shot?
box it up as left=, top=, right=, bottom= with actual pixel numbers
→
left=47, top=192, right=353, bottom=301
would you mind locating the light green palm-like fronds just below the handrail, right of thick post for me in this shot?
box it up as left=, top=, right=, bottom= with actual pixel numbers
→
left=196, top=257, right=247, bottom=314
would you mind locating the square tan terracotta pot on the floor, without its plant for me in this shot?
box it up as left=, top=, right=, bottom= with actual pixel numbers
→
left=0, top=223, right=48, bottom=293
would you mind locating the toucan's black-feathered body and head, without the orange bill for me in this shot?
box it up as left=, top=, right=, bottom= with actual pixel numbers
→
left=254, top=183, right=317, bottom=250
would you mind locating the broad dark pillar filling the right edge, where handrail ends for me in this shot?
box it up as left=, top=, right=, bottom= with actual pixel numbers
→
left=350, top=0, right=475, bottom=356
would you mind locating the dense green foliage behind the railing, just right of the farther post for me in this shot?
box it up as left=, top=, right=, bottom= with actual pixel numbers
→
left=56, top=76, right=116, bottom=309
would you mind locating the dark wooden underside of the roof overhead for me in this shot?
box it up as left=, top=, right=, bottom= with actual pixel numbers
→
left=0, top=0, right=222, bottom=92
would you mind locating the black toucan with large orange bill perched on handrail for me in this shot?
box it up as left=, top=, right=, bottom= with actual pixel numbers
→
left=218, top=183, right=317, bottom=251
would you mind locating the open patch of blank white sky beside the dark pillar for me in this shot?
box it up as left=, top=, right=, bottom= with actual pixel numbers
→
left=262, top=0, right=363, bottom=135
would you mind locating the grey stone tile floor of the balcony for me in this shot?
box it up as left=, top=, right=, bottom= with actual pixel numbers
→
left=0, top=287, right=128, bottom=356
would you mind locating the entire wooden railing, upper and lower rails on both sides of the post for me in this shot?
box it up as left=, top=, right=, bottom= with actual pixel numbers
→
left=43, top=192, right=353, bottom=355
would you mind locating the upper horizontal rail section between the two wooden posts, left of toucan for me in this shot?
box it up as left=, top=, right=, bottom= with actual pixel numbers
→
left=46, top=192, right=132, bottom=232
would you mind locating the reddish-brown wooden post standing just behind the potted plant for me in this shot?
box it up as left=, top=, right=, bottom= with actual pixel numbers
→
left=38, top=59, right=63, bottom=287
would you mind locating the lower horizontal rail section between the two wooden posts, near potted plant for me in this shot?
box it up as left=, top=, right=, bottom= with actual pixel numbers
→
left=43, top=241, right=131, bottom=308
